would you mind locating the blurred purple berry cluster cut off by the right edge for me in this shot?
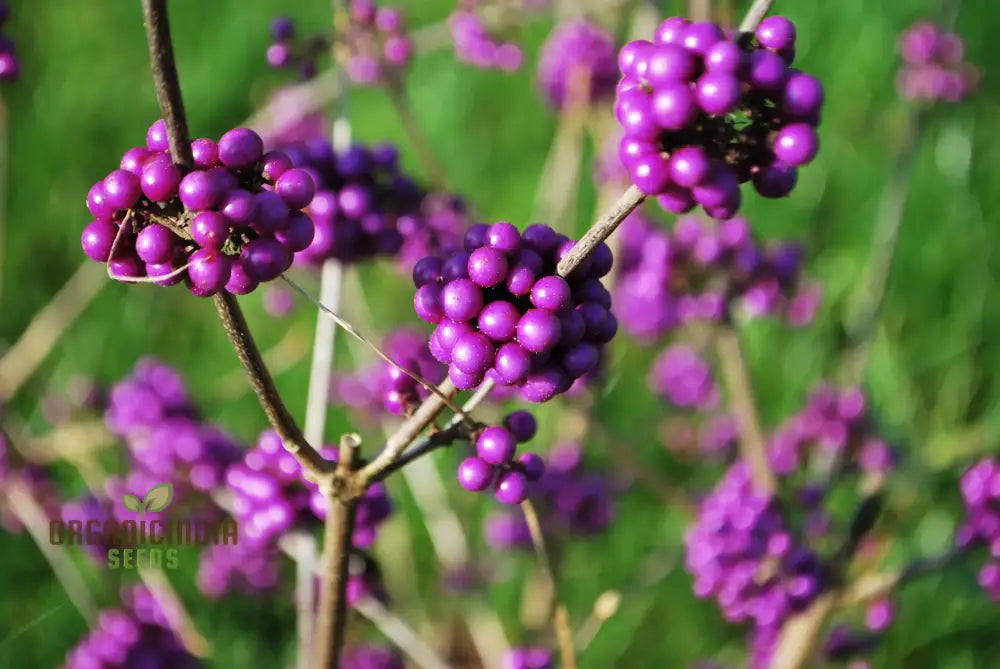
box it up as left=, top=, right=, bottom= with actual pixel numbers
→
left=955, top=457, right=1000, bottom=602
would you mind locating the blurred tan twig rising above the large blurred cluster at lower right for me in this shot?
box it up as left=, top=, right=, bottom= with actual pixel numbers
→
left=715, top=322, right=777, bottom=495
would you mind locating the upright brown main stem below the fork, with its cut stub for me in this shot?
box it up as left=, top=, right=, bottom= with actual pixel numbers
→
left=315, top=434, right=361, bottom=669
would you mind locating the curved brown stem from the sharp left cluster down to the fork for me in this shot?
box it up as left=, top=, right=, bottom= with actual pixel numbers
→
left=215, top=291, right=330, bottom=478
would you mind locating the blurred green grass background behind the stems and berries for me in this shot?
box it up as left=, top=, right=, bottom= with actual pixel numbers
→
left=0, top=0, right=1000, bottom=669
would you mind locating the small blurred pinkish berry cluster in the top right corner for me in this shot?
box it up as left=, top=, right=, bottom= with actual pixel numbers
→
left=896, top=21, right=979, bottom=102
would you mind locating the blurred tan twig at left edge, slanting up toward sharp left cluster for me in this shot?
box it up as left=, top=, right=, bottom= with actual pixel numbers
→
left=0, top=260, right=107, bottom=400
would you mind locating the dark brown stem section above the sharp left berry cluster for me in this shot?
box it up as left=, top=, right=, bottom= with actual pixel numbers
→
left=142, top=0, right=194, bottom=168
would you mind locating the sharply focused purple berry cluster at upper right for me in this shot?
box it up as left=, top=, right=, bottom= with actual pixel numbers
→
left=615, top=16, right=823, bottom=219
